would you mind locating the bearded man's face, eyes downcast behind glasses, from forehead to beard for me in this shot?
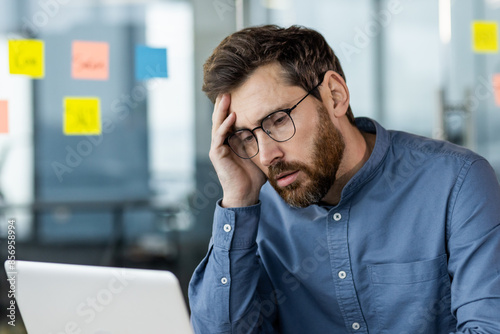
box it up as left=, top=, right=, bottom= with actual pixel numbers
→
left=230, top=64, right=345, bottom=207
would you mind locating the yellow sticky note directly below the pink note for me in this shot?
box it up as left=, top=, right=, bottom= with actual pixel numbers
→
left=64, top=97, right=101, bottom=135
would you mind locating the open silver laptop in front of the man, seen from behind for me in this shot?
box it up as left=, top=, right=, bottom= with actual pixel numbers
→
left=5, top=261, right=193, bottom=334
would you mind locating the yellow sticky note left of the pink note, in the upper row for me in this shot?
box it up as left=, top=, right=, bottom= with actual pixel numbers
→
left=9, top=39, right=45, bottom=78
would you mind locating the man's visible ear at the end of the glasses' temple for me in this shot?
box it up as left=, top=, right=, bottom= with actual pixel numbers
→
left=320, top=71, right=350, bottom=118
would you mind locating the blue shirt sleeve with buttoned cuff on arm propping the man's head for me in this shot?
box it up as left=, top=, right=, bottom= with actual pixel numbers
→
left=189, top=201, right=280, bottom=333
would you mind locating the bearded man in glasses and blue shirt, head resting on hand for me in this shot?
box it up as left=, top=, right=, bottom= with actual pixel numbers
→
left=189, top=26, right=500, bottom=334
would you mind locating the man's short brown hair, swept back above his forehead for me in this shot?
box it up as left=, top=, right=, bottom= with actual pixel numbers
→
left=202, top=25, right=355, bottom=124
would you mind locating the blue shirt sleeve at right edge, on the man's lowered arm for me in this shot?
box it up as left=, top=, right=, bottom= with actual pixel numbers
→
left=448, top=159, right=500, bottom=334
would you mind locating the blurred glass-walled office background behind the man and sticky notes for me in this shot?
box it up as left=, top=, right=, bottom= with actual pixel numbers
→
left=0, top=0, right=500, bottom=333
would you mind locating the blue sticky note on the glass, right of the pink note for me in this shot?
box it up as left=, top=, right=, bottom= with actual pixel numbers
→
left=135, top=45, right=168, bottom=80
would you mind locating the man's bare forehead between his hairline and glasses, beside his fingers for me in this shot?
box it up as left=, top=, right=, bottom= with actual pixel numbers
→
left=229, top=64, right=305, bottom=128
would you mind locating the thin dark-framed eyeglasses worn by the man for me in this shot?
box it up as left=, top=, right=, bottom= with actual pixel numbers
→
left=226, top=82, right=321, bottom=159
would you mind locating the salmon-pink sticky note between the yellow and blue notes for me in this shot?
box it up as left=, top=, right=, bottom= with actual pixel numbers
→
left=71, top=41, right=109, bottom=80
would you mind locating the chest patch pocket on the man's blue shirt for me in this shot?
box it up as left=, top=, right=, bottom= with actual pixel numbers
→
left=368, top=254, right=453, bottom=334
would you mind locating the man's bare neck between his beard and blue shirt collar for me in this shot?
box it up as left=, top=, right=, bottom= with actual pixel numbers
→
left=322, top=128, right=376, bottom=205
